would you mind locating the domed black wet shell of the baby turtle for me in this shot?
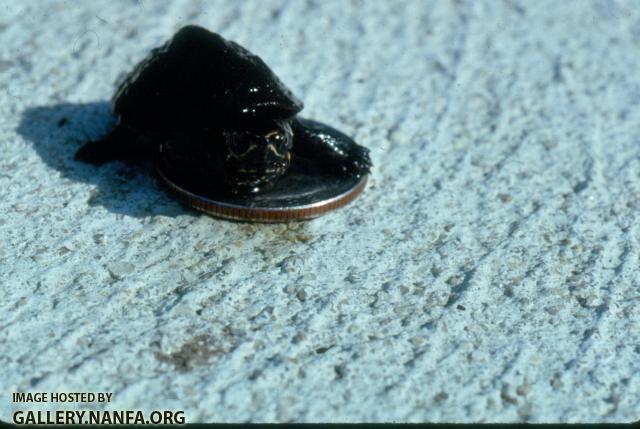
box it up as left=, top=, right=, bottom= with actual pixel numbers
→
left=112, top=26, right=303, bottom=134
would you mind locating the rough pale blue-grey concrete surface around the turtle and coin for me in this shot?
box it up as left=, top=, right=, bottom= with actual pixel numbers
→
left=0, top=0, right=640, bottom=422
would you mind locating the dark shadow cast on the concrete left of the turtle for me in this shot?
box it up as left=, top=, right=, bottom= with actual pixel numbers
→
left=16, top=102, right=195, bottom=217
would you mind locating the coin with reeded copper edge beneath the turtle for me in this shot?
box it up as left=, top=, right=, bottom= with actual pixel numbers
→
left=156, top=154, right=368, bottom=222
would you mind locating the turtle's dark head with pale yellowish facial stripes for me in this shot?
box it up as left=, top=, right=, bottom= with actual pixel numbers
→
left=223, top=120, right=293, bottom=194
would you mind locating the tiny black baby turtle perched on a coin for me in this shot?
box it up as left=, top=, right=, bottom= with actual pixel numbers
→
left=76, top=26, right=371, bottom=196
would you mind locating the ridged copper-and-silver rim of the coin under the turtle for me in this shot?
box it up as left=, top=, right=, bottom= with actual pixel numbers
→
left=156, top=168, right=368, bottom=222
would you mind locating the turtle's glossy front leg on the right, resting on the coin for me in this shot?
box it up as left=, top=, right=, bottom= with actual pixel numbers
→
left=291, top=118, right=371, bottom=177
